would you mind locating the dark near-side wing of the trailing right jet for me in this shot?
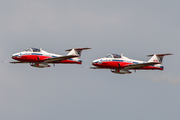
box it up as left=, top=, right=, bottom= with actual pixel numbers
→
left=124, top=62, right=160, bottom=69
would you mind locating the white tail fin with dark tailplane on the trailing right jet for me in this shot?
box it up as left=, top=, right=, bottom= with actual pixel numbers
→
left=147, top=53, right=173, bottom=63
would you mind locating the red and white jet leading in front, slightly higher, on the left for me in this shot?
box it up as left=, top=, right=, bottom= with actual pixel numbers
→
left=10, top=48, right=91, bottom=68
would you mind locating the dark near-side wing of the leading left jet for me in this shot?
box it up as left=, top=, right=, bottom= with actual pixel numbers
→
left=44, top=55, right=78, bottom=63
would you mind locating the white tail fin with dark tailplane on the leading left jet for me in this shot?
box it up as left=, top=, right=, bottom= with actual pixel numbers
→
left=66, top=48, right=91, bottom=58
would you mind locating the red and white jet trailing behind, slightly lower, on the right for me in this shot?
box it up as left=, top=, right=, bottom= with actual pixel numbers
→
left=90, top=53, right=172, bottom=74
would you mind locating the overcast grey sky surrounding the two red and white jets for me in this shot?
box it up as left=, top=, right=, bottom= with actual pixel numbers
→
left=0, top=0, right=180, bottom=120
